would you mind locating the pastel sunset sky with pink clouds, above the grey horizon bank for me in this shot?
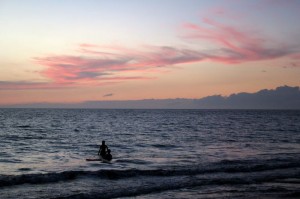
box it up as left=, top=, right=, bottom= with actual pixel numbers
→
left=0, top=0, right=300, bottom=105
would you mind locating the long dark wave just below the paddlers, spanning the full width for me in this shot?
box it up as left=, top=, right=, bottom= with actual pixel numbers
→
left=0, top=156, right=300, bottom=187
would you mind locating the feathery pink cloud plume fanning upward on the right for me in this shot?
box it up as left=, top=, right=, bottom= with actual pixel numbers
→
left=183, top=18, right=294, bottom=63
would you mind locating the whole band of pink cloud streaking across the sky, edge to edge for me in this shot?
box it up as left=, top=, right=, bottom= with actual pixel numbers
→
left=4, top=8, right=300, bottom=89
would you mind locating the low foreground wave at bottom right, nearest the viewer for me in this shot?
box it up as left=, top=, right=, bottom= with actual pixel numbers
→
left=53, top=166, right=300, bottom=199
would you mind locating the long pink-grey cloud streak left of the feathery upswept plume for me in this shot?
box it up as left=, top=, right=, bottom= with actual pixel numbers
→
left=34, top=44, right=204, bottom=88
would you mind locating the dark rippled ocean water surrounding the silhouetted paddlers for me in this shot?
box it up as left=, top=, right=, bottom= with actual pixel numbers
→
left=0, top=109, right=300, bottom=199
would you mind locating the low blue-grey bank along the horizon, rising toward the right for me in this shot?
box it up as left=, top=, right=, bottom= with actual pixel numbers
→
left=2, top=86, right=300, bottom=109
